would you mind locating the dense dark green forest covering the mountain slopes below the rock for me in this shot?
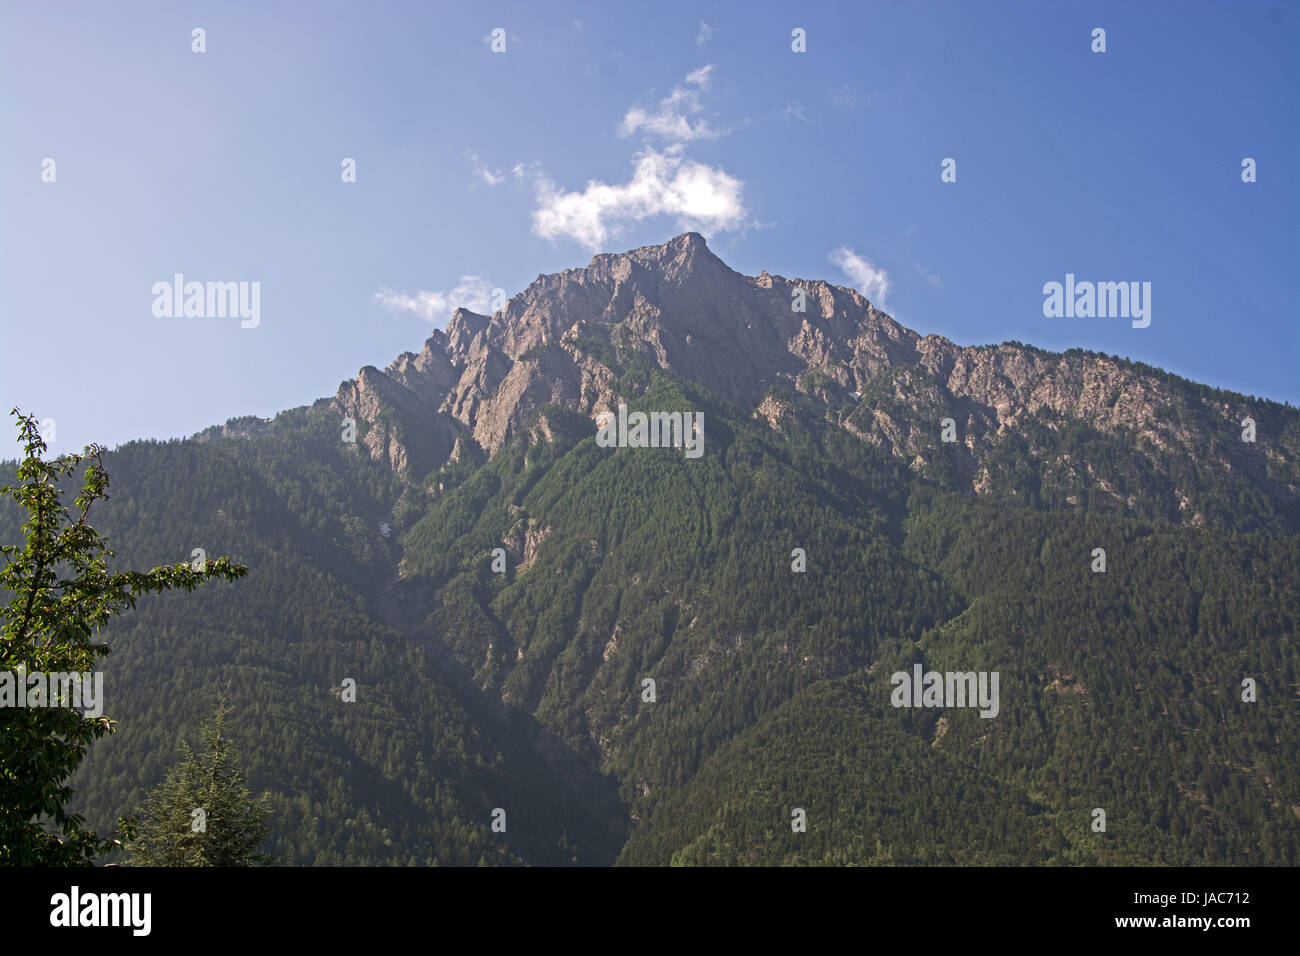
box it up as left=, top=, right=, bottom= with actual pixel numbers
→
left=0, top=359, right=1300, bottom=865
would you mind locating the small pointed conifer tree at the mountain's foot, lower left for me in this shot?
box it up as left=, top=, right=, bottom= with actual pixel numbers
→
left=122, top=704, right=273, bottom=866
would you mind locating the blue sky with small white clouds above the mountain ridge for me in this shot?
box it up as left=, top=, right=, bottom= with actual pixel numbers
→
left=0, top=0, right=1300, bottom=455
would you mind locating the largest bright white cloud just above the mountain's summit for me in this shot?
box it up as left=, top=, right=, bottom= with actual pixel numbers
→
left=533, top=146, right=746, bottom=251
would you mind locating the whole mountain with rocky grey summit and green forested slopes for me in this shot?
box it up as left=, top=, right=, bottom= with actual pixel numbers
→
left=0, top=233, right=1300, bottom=865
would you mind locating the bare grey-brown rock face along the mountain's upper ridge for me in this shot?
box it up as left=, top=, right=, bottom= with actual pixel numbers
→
left=334, top=233, right=1300, bottom=522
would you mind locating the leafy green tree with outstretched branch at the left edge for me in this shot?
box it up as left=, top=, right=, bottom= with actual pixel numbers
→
left=0, top=408, right=247, bottom=865
